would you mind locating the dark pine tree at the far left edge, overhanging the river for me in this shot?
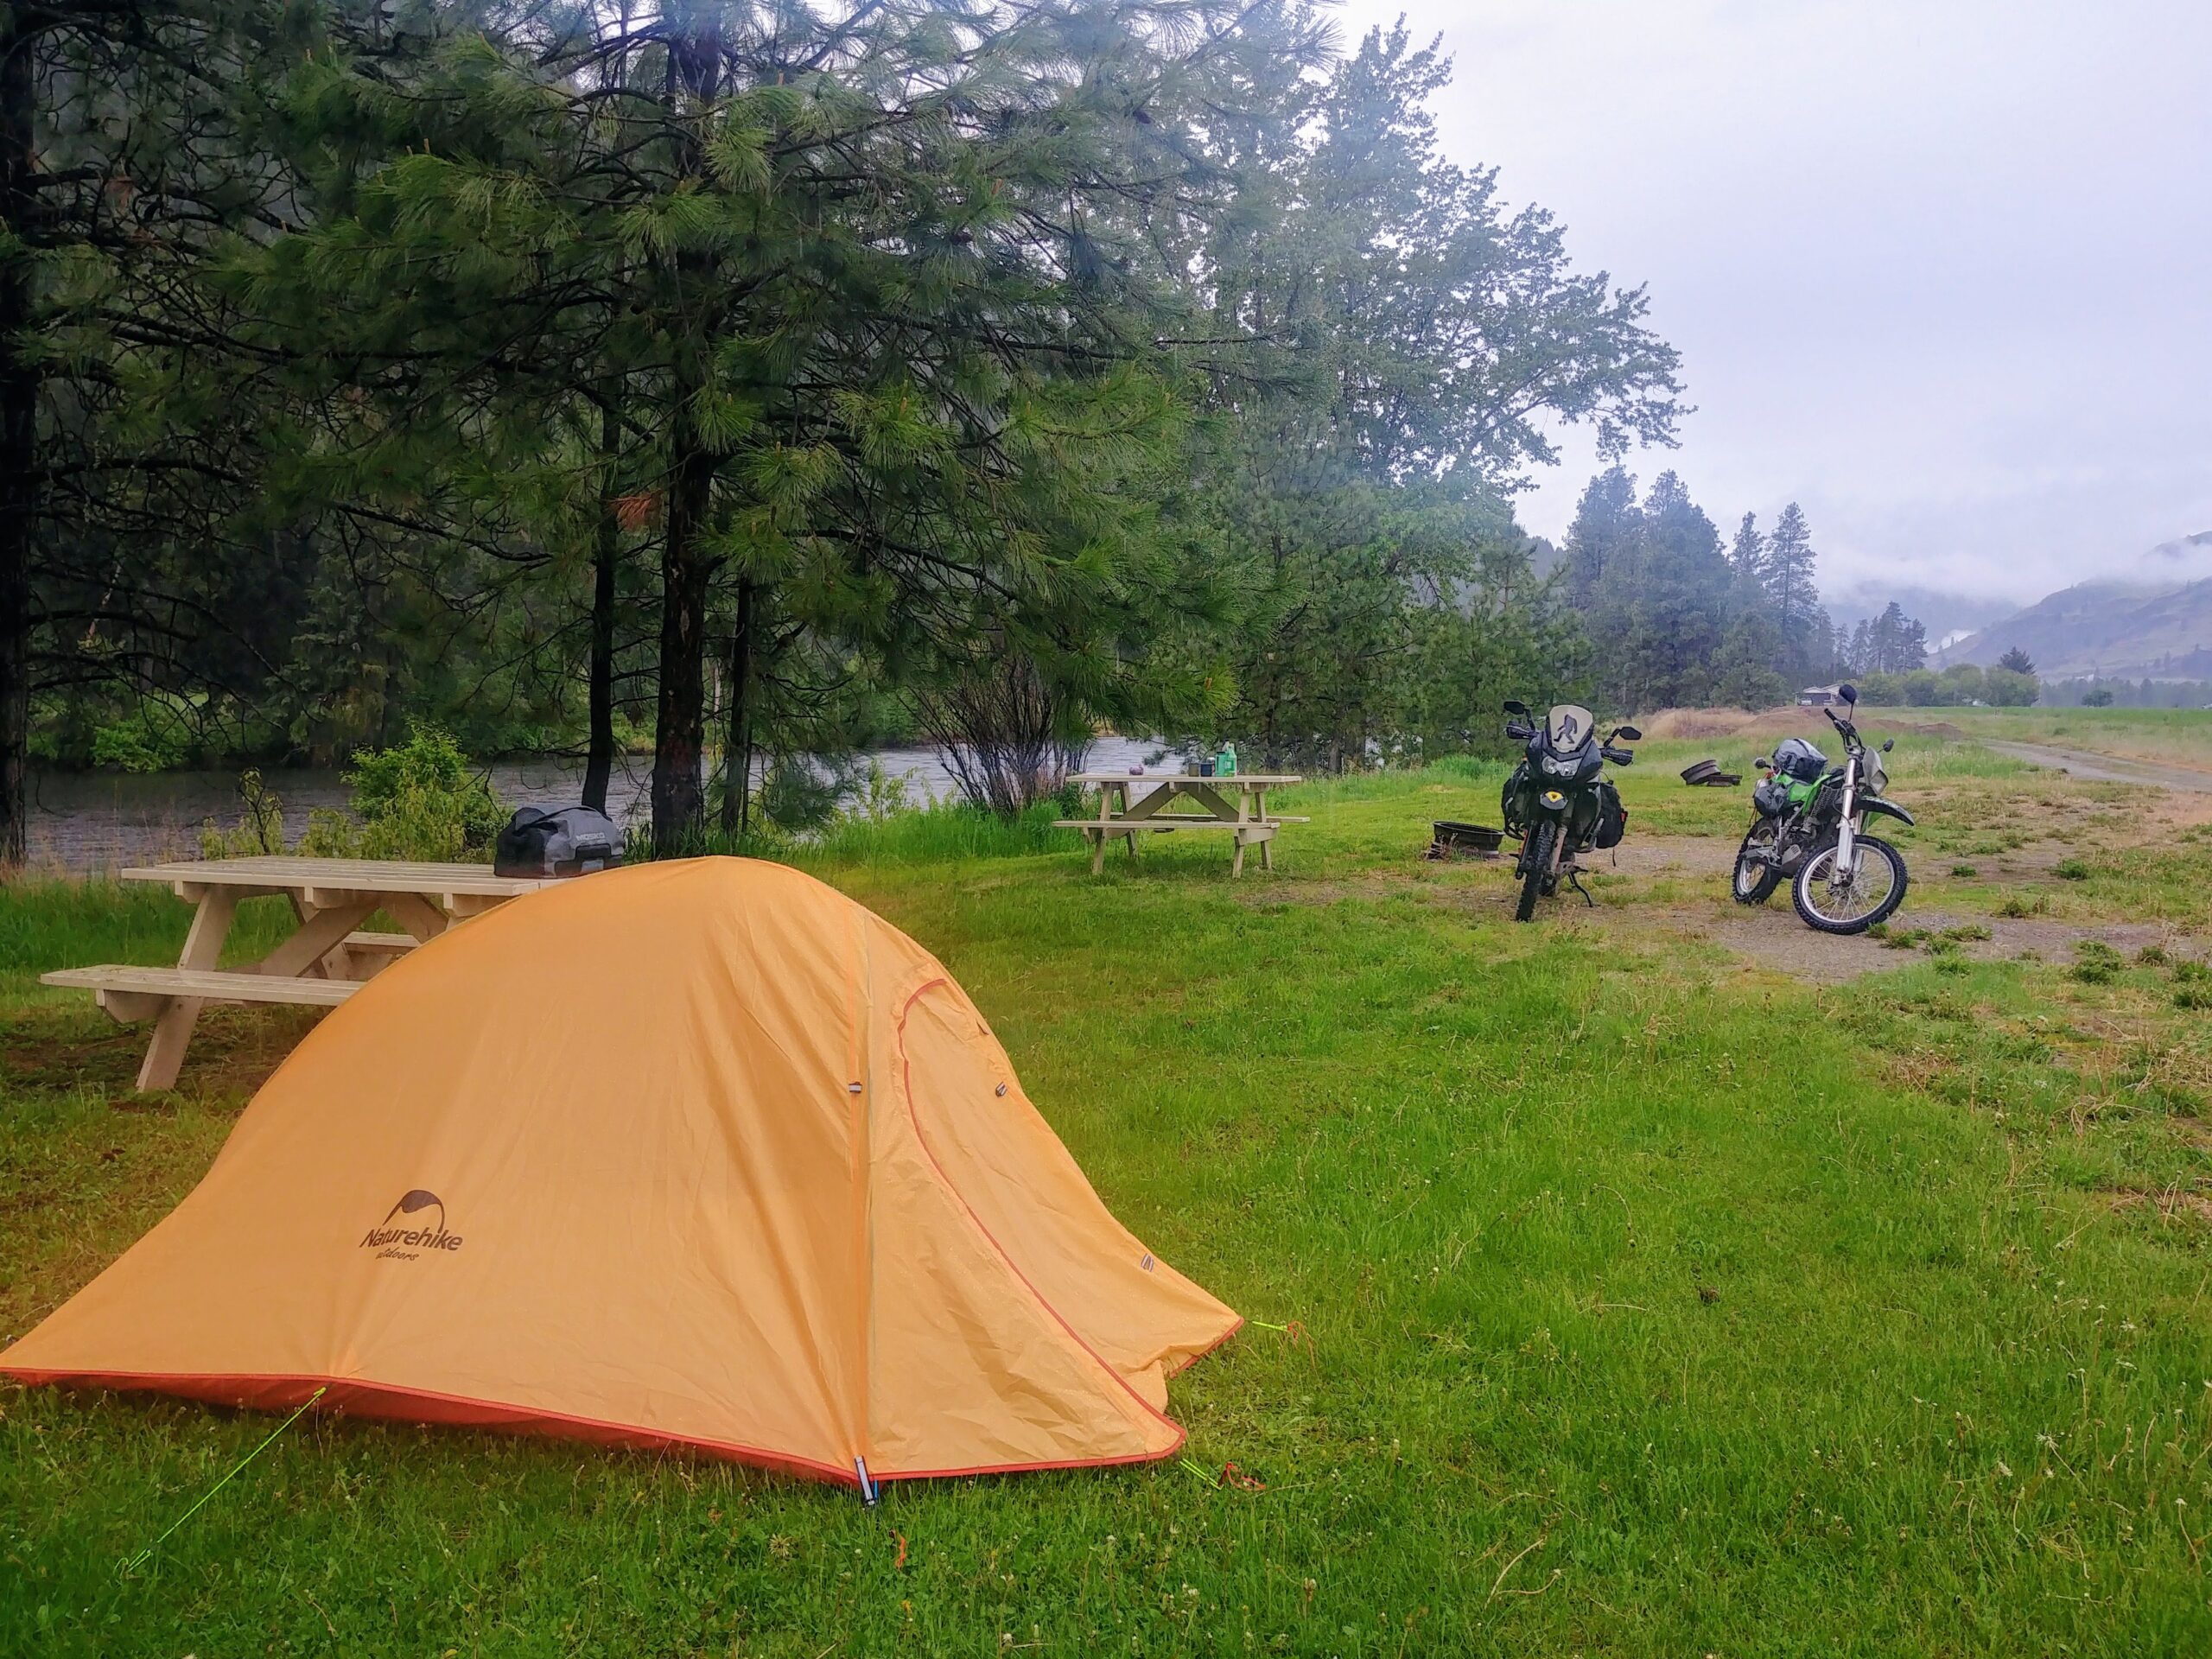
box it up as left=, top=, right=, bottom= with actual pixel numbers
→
left=0, top=0, right=294, bottom=868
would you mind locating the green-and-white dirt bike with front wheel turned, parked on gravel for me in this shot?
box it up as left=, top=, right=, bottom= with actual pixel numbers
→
left=1734, top=686, right=1913, bottom=933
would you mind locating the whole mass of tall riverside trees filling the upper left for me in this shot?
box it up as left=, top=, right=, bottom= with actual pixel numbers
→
left=0, top=0, right=1679, bottom=861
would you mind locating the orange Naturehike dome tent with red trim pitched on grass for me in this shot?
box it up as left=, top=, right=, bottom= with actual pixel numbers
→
left=0, top=858, right=1239, bottom=1489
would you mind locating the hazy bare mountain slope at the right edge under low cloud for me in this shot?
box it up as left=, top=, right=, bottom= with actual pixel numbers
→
left=1964, top=542, right=2212, bottom=679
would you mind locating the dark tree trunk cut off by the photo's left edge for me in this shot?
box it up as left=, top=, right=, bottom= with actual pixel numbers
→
left=0, top=3, right=38, bottom=865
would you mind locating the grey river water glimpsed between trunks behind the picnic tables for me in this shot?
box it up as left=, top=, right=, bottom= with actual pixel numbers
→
left=29, top=736, right=1164, bottom=874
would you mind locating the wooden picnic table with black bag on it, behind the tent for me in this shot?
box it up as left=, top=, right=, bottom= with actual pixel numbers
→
left=40, top=856, right=549, bottom=1090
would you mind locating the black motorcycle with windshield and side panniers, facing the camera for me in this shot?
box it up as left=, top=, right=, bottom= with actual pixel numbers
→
left=1497, top=696, right=1643, bottom=923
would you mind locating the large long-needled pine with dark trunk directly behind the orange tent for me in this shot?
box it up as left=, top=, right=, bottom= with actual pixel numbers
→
left=252, top=0, right=1292, bottom=849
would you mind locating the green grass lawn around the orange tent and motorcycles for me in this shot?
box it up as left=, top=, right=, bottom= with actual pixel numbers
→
left=0, top=739, right=2212, bottom=1659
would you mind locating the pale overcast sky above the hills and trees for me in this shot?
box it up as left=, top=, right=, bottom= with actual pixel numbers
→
left=1340, top=0, right=2212, bottom=600
